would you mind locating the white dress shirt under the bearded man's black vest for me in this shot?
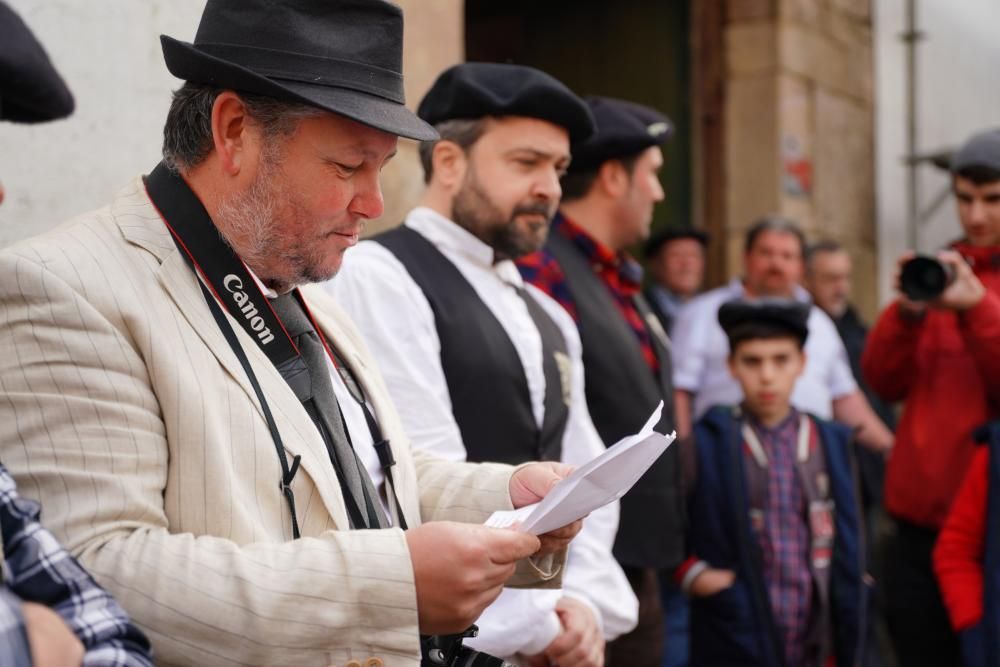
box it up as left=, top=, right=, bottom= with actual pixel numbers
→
left=326, top=208, right=638, bottom=657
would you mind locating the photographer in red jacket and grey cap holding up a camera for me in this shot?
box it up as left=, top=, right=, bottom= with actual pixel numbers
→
left=862, top=130, right=1000, bottom=667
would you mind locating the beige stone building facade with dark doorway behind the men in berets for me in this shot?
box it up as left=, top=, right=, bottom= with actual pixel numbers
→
left=373, top=0, right=877, bottom=316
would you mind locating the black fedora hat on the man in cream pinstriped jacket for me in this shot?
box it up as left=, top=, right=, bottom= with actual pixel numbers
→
left=160, top=0, right=437, bottom=140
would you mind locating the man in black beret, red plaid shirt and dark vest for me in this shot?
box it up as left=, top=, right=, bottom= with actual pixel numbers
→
left=518, top=98, right=684, bottom=667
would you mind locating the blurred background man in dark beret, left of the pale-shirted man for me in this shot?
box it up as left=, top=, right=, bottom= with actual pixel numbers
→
left=643, top=227, right=708, bottom=334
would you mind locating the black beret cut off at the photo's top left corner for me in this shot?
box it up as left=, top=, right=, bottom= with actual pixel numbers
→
left=0, top=1, right=73, bottom=123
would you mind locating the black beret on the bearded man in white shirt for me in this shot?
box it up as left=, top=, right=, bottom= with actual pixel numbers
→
left=417, top=63, right=594, bottom=142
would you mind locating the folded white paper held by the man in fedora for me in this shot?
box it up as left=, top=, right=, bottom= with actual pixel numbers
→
left=486, top=401, right=677, bottom=535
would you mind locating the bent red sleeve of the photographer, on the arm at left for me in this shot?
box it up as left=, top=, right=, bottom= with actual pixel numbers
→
left=861, top=303, right=927, bottom=402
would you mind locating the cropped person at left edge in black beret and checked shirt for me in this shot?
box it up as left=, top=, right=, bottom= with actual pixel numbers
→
left=0, top=2, right=152, bottom=667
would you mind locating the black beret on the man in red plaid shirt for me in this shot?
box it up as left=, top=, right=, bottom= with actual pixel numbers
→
left=569, top=97, right=674, bottom=172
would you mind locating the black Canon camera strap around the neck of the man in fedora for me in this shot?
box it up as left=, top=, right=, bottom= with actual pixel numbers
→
left=145, top=163, right=407, bottom=538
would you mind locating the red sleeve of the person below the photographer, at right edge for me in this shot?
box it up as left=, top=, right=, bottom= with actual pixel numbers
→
left=934, top=447, right=989, bottom=631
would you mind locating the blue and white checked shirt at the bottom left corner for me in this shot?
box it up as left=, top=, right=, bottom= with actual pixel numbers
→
left=0, top=465, right=153, bottom=667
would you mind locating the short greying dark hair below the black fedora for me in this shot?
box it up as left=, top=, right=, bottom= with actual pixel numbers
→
left=163, top=81, right=324, bottom=171
